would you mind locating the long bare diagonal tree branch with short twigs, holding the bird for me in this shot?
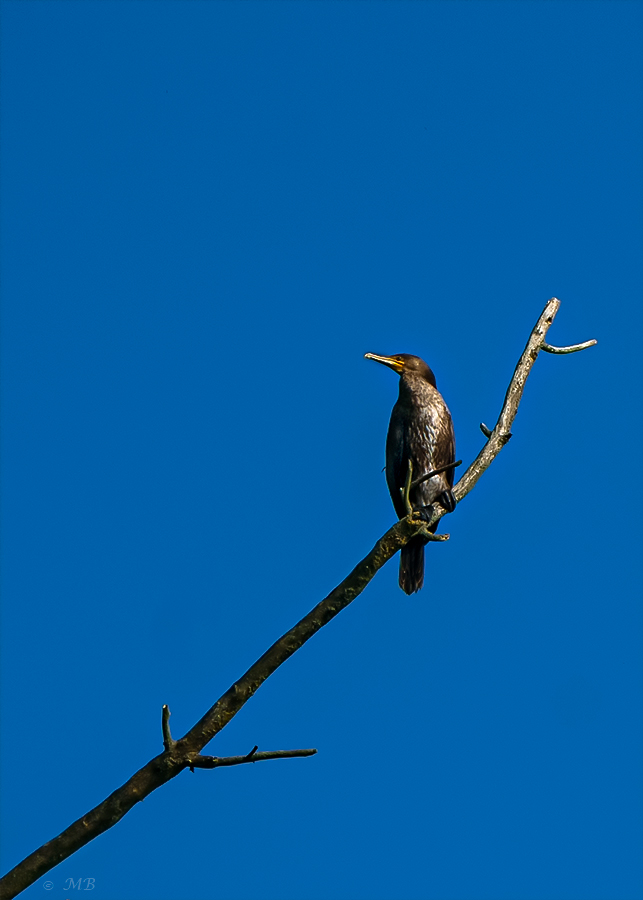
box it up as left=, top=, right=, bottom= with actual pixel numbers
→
left=0, top=297, right=595, bottom=900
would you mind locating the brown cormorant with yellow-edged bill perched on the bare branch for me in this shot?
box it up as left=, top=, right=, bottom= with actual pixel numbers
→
left=365, top=353, right=456, bottom=594
